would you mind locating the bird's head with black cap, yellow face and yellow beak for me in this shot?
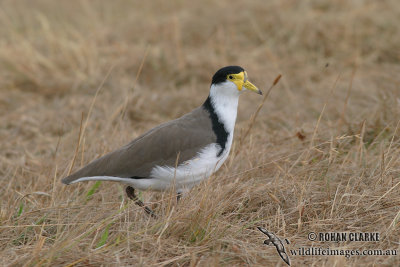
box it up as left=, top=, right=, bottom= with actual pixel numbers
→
left=211, top=66, right=262, bottom=95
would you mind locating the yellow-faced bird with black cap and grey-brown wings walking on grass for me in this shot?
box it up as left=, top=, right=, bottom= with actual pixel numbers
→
left=62, top=66, right=262, bottom=215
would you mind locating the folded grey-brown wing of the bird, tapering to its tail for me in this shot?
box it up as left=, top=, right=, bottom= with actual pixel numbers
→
left=62, top=107, right=216, bottom=184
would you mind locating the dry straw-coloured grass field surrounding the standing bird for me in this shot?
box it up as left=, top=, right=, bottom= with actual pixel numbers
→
left=0, top=0, right=400, bottom=266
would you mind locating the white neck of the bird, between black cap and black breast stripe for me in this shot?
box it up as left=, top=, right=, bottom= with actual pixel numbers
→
left=210, top=82, right=240, bottom=134
